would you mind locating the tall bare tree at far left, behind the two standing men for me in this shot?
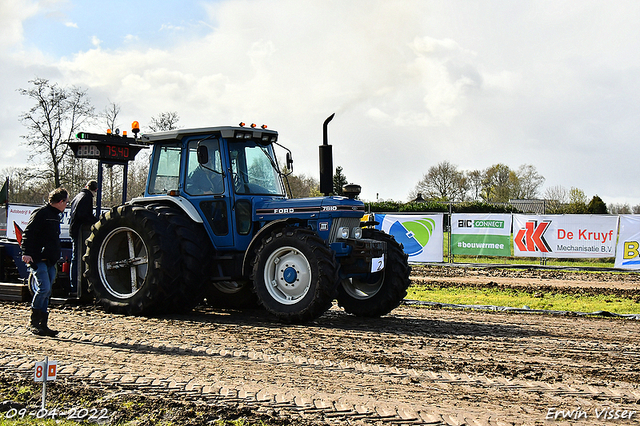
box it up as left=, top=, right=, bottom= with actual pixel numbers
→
left=18, top=78, right=95, bottom=187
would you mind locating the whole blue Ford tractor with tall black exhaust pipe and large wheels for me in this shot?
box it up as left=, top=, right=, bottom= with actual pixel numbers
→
left=83, top=115, right=410, bottom=322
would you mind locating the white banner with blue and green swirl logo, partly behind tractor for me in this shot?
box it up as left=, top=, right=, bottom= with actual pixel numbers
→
left=374, top=213, right=444, bottom=262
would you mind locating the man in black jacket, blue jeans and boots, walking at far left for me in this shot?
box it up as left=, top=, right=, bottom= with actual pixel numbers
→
left=22, top=188, right=69, bottom=337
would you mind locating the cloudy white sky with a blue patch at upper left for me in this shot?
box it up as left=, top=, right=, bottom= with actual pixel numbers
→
left=0, top=0, right=640, bottom=206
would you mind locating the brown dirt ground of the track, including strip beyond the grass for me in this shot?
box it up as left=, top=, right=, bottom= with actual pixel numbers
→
left=0, top=267, right=640, bottom=425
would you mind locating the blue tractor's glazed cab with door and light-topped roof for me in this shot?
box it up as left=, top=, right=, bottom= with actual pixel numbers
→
left=142, top=126, right=290, bottom=251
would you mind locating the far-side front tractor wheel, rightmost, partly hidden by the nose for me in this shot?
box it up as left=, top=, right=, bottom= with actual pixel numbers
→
left=338, top=228, right=411, bottom=317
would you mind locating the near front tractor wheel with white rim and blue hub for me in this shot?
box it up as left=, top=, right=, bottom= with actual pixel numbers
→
left=252, top=227, right=338, bottom=323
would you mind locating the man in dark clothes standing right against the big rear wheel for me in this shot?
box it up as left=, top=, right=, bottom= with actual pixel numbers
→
left=69, top=180, right=98, bottom=295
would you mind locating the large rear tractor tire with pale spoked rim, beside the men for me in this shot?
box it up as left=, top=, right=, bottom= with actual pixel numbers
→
left=83, top=205, right=181, bottom=315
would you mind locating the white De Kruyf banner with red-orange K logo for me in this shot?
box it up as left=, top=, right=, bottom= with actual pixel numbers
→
left=513, top=214, right=618, bottom=258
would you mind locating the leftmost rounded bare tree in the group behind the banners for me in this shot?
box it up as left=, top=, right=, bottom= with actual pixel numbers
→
left=414, top=161, right=468, bottom=201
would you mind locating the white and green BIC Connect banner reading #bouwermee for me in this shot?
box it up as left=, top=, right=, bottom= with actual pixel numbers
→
left=451, top=213, right=511, bottom=256
